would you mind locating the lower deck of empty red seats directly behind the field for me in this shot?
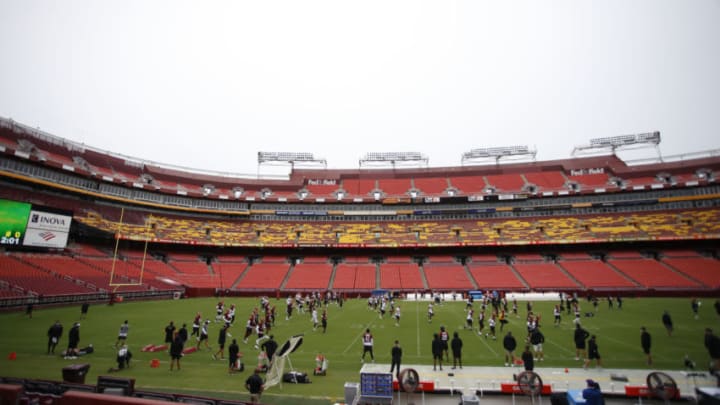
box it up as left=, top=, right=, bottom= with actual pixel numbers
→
left=0, top=249, right=720, bottom=297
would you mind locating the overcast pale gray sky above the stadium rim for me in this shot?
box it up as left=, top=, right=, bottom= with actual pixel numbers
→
left=0, top=0, right=720, bottom=173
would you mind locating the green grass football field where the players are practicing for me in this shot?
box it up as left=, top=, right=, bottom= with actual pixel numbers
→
left=0, top=298, right=718, bottom=404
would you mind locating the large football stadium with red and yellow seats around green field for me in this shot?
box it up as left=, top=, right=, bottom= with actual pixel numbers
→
left=0, top=114, right=720, bottom=404
